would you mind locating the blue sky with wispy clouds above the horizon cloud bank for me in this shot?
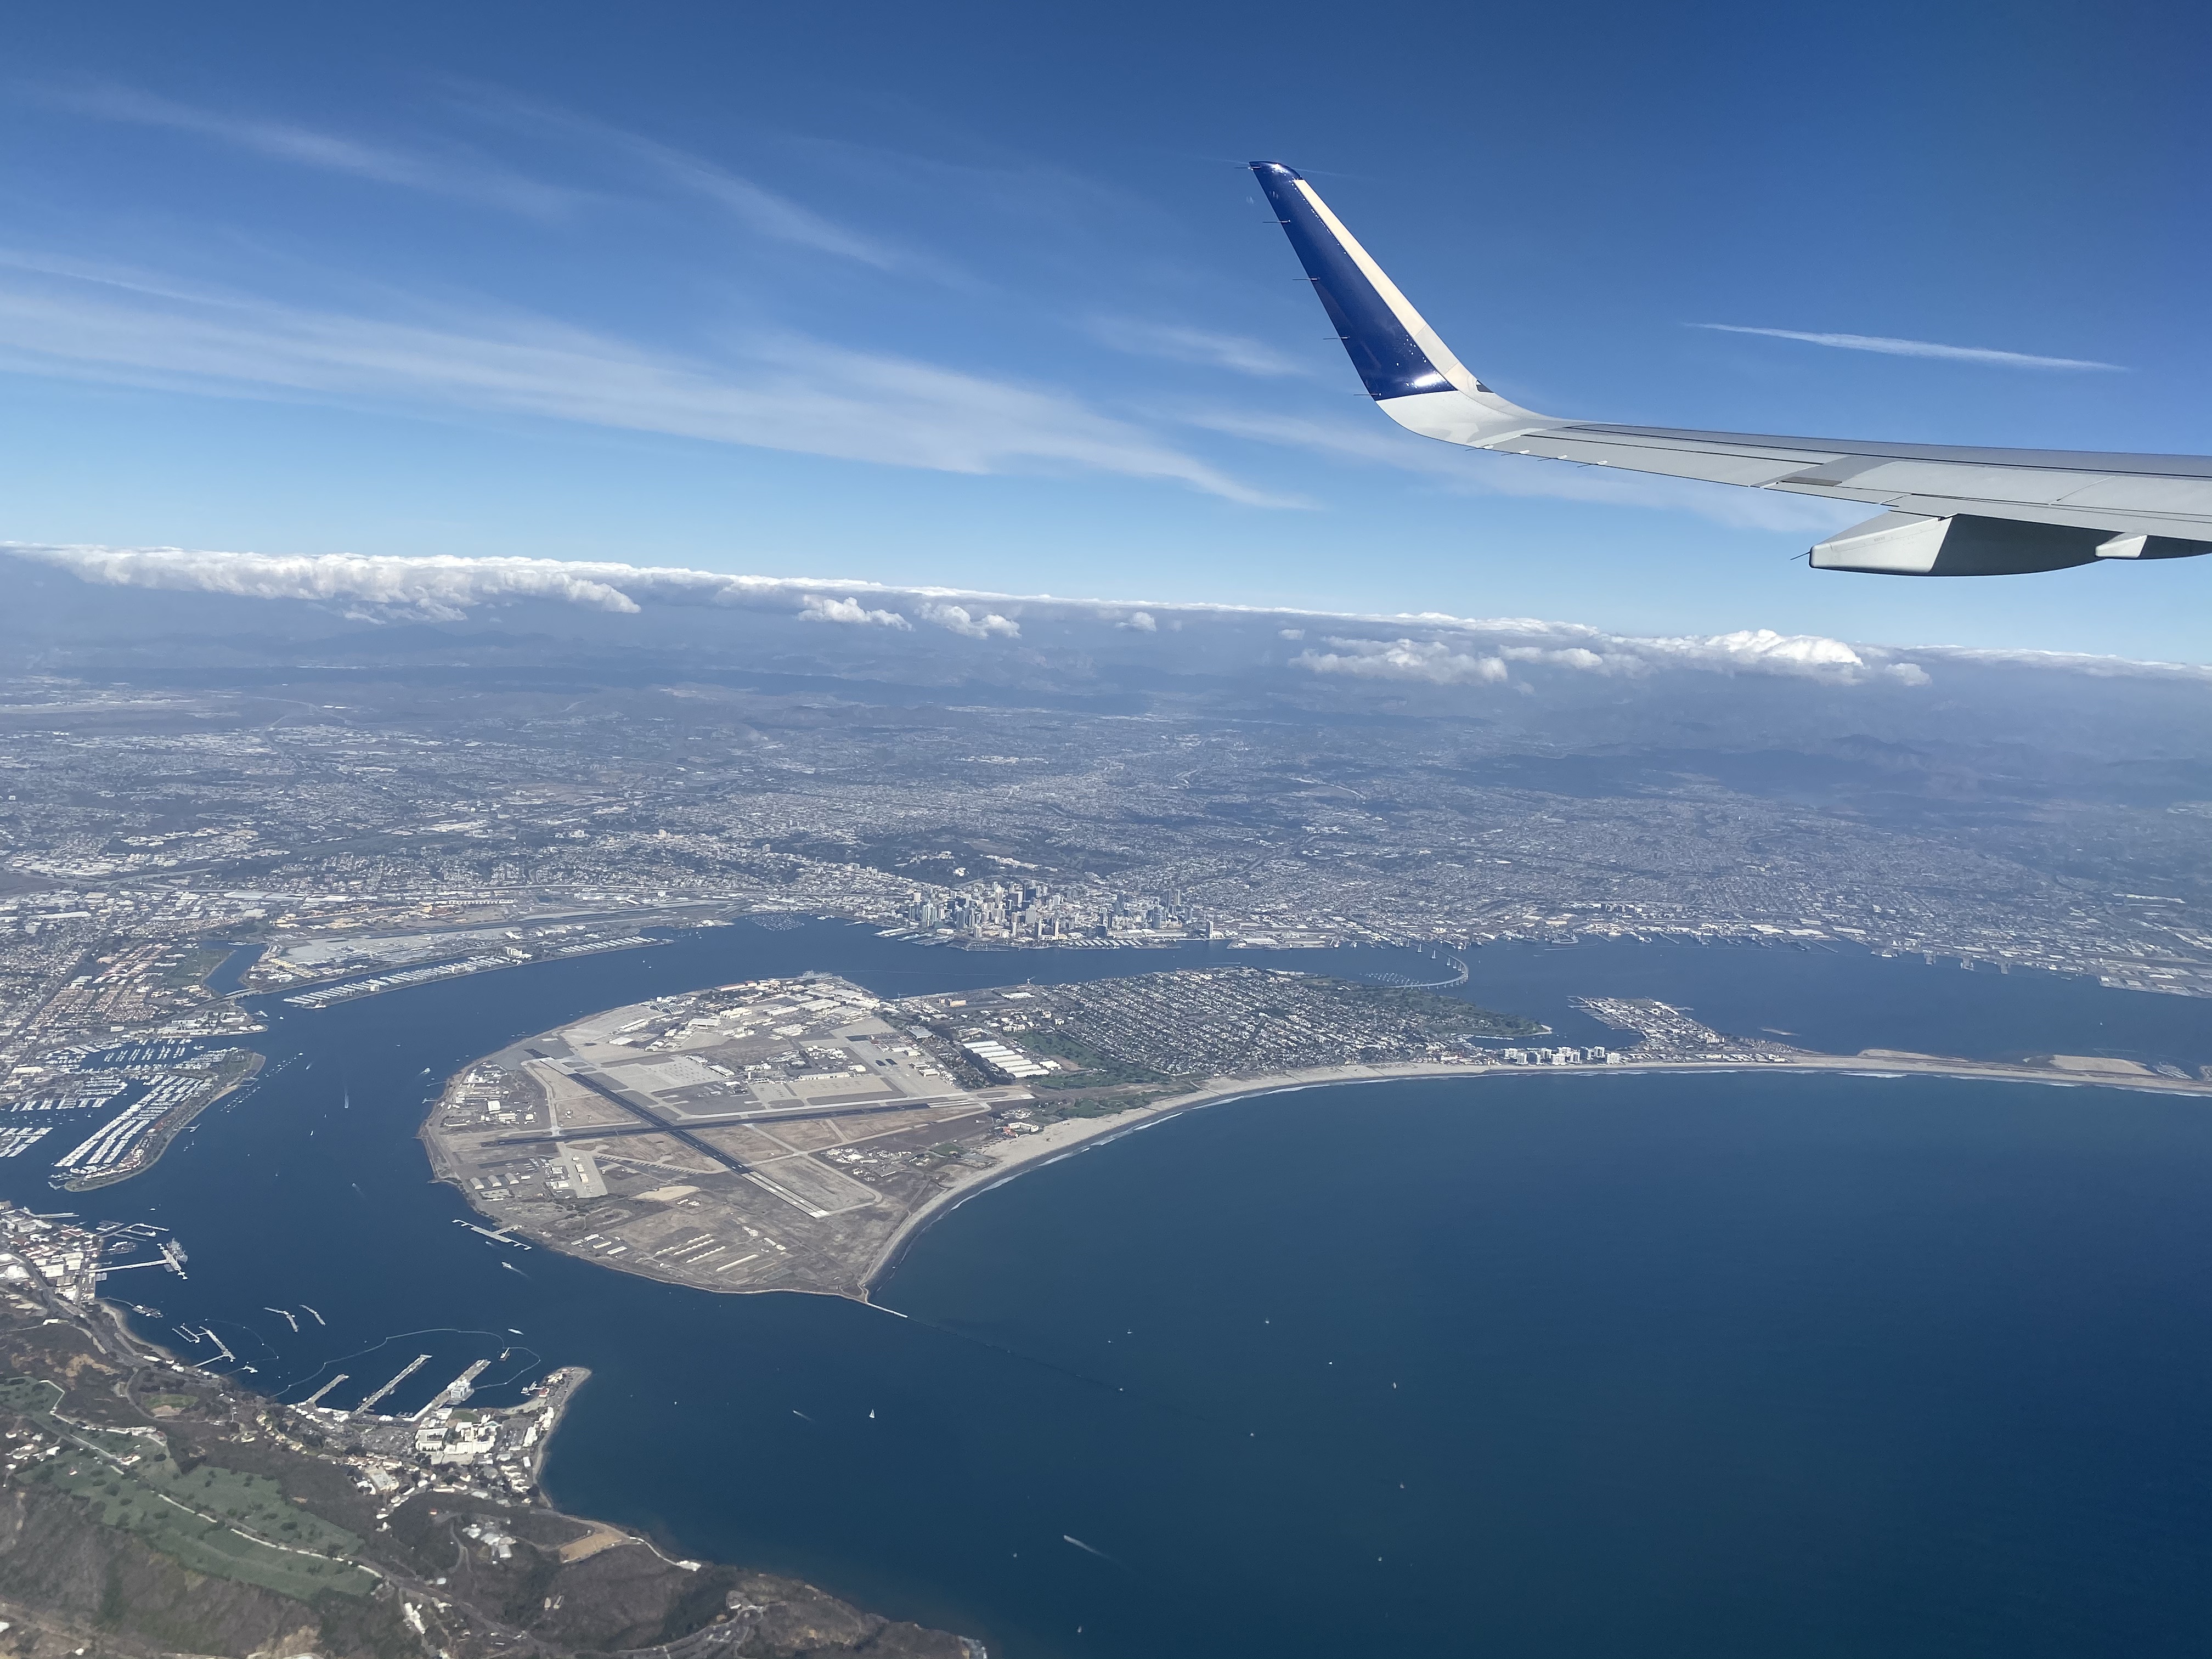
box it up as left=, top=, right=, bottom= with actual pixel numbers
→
left=0, top=4, right=2212, bottom=662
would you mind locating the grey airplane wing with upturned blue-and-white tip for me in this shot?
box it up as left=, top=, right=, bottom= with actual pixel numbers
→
left=1252, top=161, right=2212, bottom=575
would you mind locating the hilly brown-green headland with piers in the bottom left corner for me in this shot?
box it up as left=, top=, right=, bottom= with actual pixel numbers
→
left=0, top=1203, right=982, bottom=1659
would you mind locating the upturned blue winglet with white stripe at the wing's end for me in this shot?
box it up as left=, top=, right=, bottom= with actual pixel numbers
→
left=1252, top=161, right=1544, bottom=442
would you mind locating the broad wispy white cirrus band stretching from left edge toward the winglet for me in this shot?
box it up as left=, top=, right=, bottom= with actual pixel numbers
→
left=0, top=252, right=1294, bottom=506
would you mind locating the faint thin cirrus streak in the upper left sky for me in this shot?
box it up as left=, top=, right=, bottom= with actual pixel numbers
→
left=36, top=84, right=584, bottom=219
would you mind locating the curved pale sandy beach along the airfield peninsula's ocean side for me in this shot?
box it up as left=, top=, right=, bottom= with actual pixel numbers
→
left=854, top=1048, right=2212, bottom=1314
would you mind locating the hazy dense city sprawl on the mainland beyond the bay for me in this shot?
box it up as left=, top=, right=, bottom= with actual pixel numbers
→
left=0, top=681, right=2212, bottom=1119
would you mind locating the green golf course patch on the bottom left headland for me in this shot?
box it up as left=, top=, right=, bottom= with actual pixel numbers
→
left=0, top=1376, right=376, bottom=1601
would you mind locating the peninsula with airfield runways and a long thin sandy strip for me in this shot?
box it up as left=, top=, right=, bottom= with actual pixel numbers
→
left=422, top=967, right=2212, bottom=1301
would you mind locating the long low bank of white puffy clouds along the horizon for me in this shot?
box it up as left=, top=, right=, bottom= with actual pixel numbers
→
left=13, top=544, right=2212, bottom=690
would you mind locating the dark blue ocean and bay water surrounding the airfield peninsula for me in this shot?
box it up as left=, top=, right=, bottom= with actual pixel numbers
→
left=0, top=924, right=2212, bottom=1659
